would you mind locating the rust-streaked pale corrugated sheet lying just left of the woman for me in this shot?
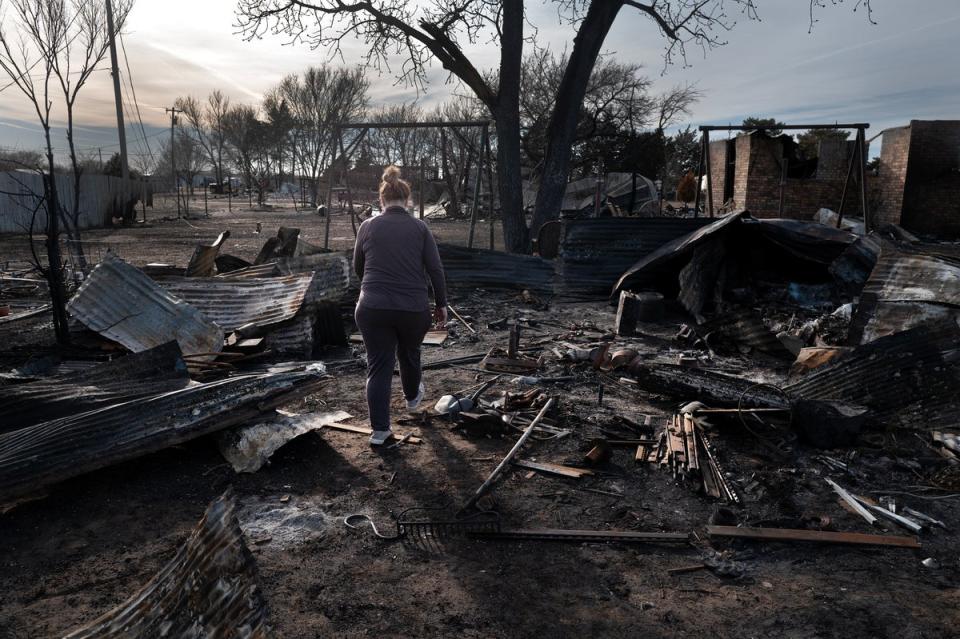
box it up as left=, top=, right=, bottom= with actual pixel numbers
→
left=160, top=275, right=313, bottom=332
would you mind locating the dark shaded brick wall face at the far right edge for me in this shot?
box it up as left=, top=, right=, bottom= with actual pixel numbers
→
left=900, top=120, right=960, bottom=238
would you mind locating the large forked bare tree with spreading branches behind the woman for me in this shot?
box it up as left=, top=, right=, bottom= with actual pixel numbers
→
left=237, top=0, right=870, bottom=251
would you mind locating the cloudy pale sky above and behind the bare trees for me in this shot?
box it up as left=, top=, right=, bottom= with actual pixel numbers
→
left=0, top=0, right=960, bottom=157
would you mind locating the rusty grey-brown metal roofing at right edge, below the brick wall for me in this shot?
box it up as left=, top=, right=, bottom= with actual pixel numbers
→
left=850, top=240, right=960, bottom=344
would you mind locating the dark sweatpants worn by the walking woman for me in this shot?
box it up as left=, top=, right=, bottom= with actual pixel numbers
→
left=354, top=304, right=431, bottom=431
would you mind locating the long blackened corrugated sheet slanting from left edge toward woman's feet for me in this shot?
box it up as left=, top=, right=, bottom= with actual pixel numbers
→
left=0, top=370, right=322, bottom=503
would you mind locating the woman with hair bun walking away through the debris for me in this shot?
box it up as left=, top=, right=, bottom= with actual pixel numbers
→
left=353, top=165, right=447, bottom=446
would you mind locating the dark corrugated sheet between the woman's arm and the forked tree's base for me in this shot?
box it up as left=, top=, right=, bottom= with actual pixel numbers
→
left=437, top=244, right=553, bottom=294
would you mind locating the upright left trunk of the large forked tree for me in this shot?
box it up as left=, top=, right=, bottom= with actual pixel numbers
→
left=492, top=0, right=530, bottom=253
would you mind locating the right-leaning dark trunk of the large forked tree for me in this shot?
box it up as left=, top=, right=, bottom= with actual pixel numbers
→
left=530, top=0, right=623, bottom=235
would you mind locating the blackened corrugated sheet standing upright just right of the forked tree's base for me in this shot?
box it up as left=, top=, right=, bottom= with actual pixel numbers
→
left=559, top=217, right=710, bottom=296
